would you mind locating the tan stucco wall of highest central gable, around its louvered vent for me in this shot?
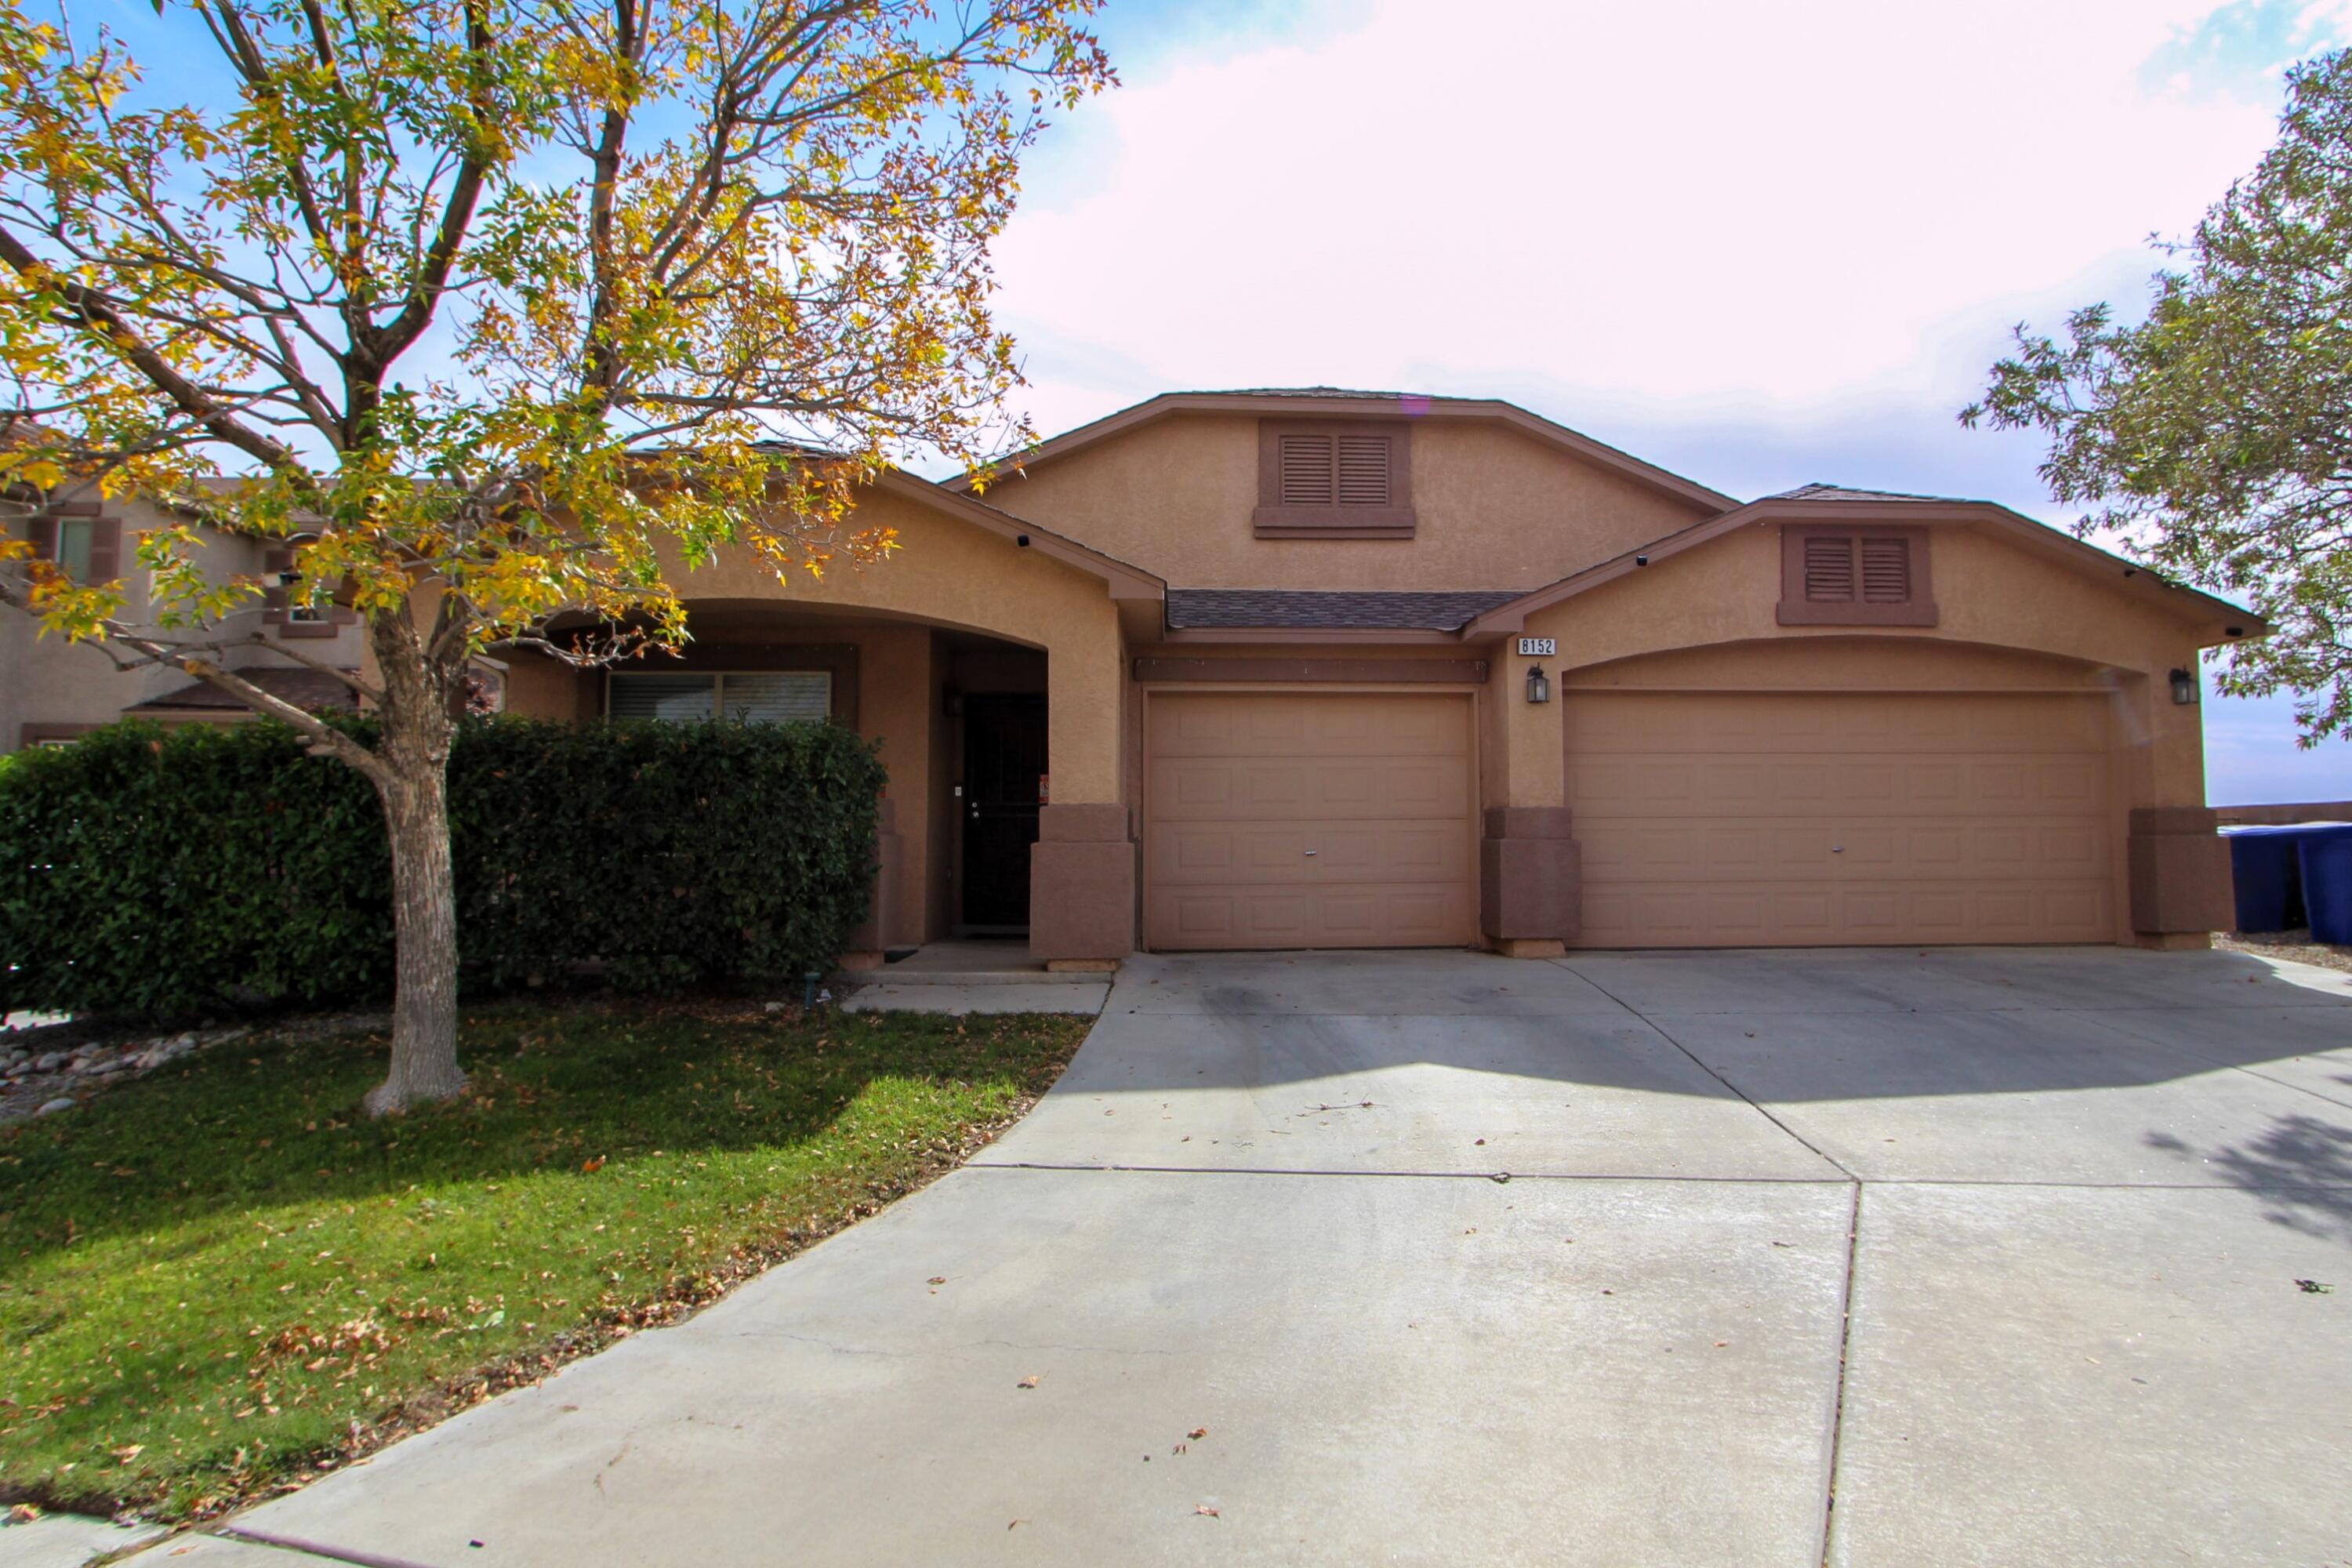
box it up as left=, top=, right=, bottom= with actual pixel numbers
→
left=983, top=414, right=1708, bottom=590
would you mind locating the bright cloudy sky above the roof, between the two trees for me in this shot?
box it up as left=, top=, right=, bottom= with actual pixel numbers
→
left=978, top=0, right=2352, bottom=801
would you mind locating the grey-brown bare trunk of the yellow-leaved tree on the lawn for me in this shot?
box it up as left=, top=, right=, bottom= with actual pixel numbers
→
left=367, top=614, right=466, bottom=1116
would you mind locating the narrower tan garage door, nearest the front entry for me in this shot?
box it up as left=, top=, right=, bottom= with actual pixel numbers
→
left=1143, top=691, right=1477, bottom=949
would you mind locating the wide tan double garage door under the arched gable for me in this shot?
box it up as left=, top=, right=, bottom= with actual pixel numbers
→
left=1564, top=691, right=2114, bottom=947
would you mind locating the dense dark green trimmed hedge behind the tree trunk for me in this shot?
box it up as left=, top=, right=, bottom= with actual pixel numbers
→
left=0, top=720, right=884, bottom=1015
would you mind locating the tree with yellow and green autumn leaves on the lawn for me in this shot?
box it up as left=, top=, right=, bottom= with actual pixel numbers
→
left=0, top=0, right=1115, bottom=1114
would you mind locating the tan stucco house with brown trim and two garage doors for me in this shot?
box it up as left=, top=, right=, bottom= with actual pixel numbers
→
left=26, top=388, right=2267, bottom=964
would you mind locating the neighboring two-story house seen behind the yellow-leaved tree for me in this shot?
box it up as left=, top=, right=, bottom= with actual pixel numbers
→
left=0, top=492, right=362, bottom=750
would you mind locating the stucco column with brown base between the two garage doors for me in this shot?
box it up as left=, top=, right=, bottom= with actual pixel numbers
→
left=1479, top=640, right=1581, bottom=959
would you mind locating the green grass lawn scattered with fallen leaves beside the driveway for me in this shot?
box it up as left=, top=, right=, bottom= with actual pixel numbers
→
left=0, top=1006, right=1084, bottom=1516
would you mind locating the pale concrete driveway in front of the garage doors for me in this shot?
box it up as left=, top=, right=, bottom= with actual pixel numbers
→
left=136, top=949, right=2352, bottom=1568
